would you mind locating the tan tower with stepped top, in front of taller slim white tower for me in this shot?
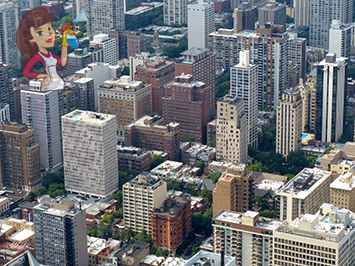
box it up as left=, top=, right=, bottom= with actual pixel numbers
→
left=216, top=95, right=249, bottom=163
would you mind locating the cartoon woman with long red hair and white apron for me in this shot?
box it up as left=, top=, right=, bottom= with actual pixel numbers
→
left=16, top=7, right=74, bottom=91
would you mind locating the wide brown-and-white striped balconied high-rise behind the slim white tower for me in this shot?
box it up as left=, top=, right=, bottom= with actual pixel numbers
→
left=209, top=26, right=289, bottom=109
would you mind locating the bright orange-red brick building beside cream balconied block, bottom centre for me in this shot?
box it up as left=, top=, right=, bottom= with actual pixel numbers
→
left=152, top=195, right=191, bottom=252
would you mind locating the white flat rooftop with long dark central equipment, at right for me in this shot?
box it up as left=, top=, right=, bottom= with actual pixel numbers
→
left=277, top=168, right=331, bottom=199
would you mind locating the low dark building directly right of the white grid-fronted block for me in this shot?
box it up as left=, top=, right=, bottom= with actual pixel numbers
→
left=117, top=146, right=150, bottom=173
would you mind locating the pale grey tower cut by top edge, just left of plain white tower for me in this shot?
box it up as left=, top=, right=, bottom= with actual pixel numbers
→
left=164, top=0, right=187, bottom=25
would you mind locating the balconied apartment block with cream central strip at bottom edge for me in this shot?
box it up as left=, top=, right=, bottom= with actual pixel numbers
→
left=212, top=211, right=281, bottom=266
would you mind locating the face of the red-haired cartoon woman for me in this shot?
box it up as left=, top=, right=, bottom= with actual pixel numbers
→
left=30, top=22, right=56, bottom=48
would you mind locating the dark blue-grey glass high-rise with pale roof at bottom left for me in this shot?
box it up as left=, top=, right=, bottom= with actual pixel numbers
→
left=33, top=198, right=88, bottom=266
